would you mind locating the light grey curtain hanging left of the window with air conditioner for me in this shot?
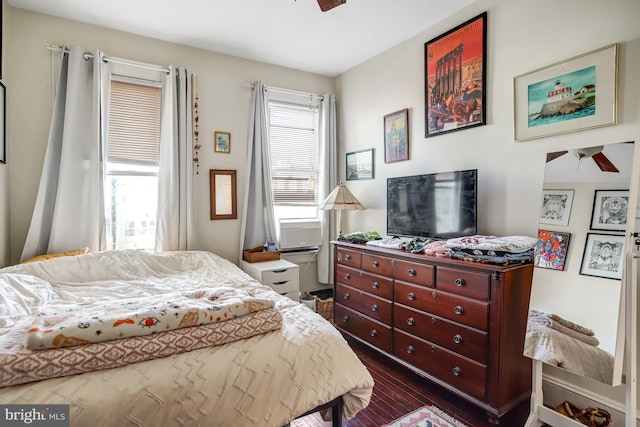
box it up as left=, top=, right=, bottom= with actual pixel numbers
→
left=239, top=81, right=276, bottom=262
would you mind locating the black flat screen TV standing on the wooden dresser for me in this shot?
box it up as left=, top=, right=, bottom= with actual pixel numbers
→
left=387, top=169, right=478, bottom=239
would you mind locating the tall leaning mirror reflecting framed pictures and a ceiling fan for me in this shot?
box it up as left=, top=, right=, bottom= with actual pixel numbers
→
left=524, top=143, right=637, bottom=385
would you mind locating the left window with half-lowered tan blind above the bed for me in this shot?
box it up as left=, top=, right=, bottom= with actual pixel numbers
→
left=105, top=79, right=162, bottom=249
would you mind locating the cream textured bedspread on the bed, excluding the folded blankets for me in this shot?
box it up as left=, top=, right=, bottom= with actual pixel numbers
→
left=0, top=251, right=373, bottom=427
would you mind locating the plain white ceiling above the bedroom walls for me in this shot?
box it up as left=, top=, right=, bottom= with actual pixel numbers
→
left=8, top=0, right=475, bottom=77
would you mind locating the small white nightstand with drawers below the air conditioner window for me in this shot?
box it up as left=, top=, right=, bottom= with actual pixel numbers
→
left=242, top=259, right=300, bottom=302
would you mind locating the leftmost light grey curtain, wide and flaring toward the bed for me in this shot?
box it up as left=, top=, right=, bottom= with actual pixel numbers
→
left=20, top=46, right=110, bottom=261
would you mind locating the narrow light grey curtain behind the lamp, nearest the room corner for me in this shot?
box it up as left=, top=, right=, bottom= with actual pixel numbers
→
left=318, top=94, right=338, bottom=284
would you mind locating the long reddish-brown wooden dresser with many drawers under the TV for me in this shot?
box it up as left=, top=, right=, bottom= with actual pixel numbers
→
left=332, top=242, right=533, bottom=424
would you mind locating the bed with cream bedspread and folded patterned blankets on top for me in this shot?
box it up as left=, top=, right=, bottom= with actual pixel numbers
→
left=0, top=250, right=373, bottom=426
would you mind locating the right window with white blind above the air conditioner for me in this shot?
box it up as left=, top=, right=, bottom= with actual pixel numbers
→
left=269, top=98, right=319, bottom=221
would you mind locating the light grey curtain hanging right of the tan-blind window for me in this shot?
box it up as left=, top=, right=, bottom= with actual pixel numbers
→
left=156, top=66, right=196, bottom=251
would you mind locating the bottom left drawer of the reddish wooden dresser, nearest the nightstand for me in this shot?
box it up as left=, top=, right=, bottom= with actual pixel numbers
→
left=334, top=302, right=391, bottom=353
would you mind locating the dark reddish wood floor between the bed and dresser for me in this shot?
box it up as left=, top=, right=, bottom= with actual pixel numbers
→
left=291, top=339, right=529, bottom=427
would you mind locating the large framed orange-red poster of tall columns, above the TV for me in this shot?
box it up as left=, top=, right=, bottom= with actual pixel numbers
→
left=424, top=12, right=487, bottom=138
